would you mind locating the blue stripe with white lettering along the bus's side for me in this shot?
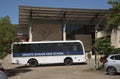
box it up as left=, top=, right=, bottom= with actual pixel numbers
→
left=13, top=51, right=83, bottom=57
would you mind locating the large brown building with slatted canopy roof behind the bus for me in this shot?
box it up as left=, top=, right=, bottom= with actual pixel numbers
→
left=17, top=6, right=108, bottom=51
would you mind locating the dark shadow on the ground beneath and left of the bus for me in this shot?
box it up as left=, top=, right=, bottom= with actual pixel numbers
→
left=6, top=63, right=86, bottom=77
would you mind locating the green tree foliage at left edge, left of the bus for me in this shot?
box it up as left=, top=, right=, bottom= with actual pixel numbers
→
left=0, top=16, right=17, bottom=58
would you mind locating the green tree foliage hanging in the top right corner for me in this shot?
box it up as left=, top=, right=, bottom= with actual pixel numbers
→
left=106, top=0, right=120, bottom=31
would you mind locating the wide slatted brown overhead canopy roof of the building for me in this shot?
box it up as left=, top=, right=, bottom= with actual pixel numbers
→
left=19, top=6, right=108, bottom=27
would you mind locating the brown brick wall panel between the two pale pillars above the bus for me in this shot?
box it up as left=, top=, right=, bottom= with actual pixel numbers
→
left=32, top=22, right=62, bottom=41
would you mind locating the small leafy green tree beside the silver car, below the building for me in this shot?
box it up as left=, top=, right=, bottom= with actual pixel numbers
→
left=93, top=37, right=120, bottom=64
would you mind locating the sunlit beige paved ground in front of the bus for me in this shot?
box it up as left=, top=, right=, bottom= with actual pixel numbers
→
left=0, top=56, right=120, bottom=79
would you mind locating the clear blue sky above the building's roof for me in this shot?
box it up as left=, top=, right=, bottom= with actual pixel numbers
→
left=0, top=0, right=111, bottom=24
